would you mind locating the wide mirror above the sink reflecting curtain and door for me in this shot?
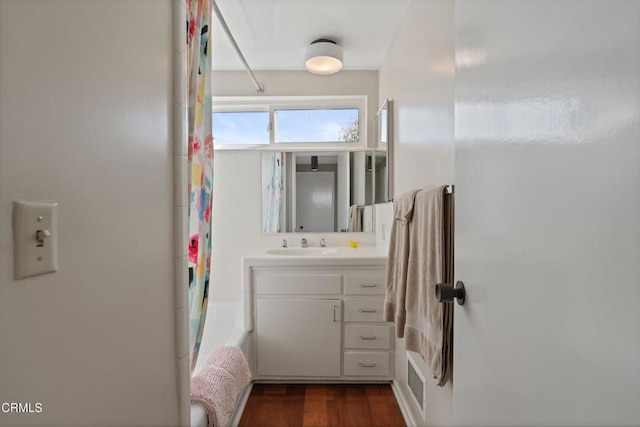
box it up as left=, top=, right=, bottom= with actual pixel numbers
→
left=262, top=150, right=388, bottom=234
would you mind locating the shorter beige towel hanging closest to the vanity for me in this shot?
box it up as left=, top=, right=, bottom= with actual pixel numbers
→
left=383, top=190, right=420, bottom=338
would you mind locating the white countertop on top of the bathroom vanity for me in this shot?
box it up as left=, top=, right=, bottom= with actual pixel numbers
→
left=242, top=246, right=388, bottom=267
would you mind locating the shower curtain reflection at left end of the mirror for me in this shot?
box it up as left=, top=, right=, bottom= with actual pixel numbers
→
left=262, top=153, right=285, bottom=233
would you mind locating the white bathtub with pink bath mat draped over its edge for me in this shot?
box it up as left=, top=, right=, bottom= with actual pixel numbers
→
left=191, top=302, right=251, bottom=427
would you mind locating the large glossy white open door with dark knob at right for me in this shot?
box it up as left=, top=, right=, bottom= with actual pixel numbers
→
left=453, top=0, right=640, bottom=426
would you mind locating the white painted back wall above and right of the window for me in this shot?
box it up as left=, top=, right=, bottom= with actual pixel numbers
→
left=213, top=70, right=378, bottom=147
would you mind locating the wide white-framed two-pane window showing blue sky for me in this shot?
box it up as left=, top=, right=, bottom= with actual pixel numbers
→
left=213, top=96, right=366, bottom=149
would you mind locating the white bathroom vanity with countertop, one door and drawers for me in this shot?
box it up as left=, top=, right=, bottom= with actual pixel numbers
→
left=244, top=247, right=394, bottom=381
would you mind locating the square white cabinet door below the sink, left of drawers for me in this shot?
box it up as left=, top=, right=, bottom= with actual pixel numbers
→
left=256, top=298, right=342, bottom=377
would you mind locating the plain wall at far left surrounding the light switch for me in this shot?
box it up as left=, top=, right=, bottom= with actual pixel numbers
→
left=0, top=0, right=178, bottom=426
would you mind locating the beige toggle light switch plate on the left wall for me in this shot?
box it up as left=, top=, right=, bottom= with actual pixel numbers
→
left=13, top=201, right=58, bottom=280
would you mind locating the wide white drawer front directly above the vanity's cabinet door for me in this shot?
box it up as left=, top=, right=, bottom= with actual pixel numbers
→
left=255, top=275, right=342, bottom=295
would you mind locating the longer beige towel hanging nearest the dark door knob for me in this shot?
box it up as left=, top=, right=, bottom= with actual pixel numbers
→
left=404, top=186, right=453, bottom=385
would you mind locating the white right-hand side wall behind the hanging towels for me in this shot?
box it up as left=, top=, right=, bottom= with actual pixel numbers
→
left=376, top=0, right=455, bottom=425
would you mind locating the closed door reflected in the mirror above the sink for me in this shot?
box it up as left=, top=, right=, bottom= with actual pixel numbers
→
left=296, top=172, right=336, bottom=232
